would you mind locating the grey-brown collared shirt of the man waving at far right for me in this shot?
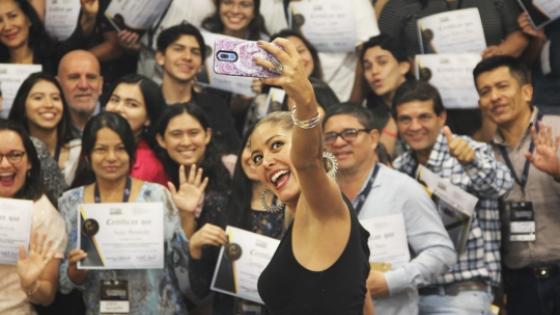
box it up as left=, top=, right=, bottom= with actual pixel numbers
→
left=493, top=108, right=560, bottom=269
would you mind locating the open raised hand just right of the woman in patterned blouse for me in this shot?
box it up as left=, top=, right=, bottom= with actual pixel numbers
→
left=167, top=164, right=208, bottom=214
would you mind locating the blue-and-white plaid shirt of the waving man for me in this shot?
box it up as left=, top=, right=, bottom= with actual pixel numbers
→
left=394, top=133, right=513, bottom=286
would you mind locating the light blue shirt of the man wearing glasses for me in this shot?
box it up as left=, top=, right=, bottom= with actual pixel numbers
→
left=352, top=164, right=457, bottom=315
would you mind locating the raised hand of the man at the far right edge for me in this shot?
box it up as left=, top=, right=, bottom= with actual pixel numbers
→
left=525, top=122, right=560, bottom=177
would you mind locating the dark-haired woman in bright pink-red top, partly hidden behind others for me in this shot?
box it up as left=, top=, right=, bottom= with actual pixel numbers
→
left=105, top=74, right=167, bottom=186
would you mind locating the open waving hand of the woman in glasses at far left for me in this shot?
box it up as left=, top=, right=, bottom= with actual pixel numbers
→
left=17, top=233, right=55, bottom=292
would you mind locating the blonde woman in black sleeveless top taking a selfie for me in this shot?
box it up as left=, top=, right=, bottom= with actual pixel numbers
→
left=250, top=38, right=369, bottom=315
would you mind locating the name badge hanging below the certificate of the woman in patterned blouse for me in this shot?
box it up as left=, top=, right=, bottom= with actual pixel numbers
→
left=99, top=280, right=130, bottom=315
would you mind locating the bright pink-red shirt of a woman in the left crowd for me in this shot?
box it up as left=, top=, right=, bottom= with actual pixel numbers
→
left=130, top=140, right=169, bottom=187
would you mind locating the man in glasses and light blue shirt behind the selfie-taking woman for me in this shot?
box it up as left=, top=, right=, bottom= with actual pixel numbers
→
left=324, top=104, right=456, bottom=315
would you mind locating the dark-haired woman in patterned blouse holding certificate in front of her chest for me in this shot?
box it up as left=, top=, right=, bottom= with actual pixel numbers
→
left=59, top=112, right=197, bottom=315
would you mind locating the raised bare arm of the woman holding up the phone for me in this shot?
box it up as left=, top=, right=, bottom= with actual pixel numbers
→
left=256, top=38, right=348, bottom=220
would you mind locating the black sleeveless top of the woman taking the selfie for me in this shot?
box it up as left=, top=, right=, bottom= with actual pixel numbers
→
left=258, top=202, right=369, bottom=315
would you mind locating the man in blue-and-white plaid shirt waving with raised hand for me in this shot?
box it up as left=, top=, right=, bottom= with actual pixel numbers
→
left=391, top=81, right=513, bottom=315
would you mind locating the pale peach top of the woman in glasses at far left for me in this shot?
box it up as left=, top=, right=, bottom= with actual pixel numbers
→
left=0, top=195, right=67, bottom=315
